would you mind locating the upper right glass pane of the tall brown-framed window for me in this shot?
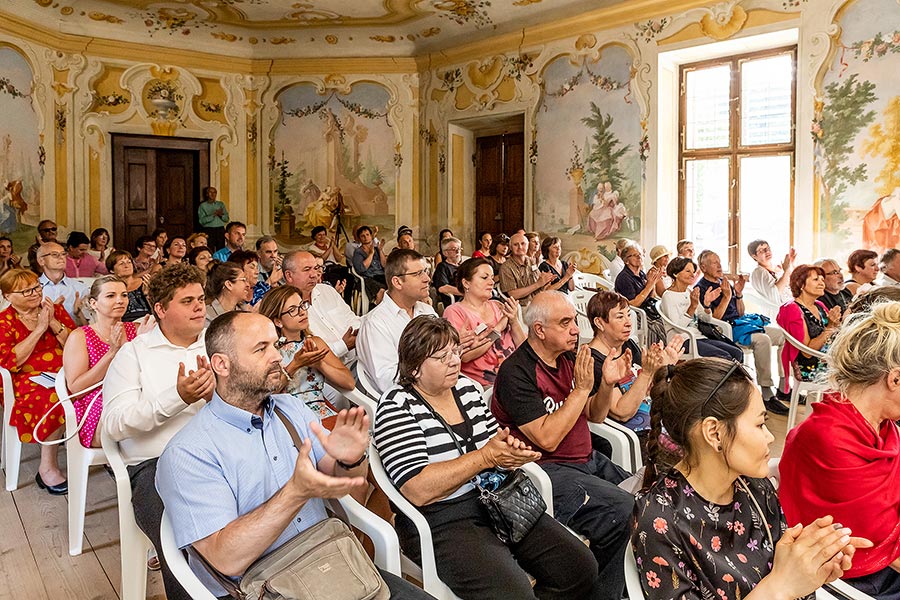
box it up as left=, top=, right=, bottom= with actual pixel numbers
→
left=741, top=54, right=794, bottom=146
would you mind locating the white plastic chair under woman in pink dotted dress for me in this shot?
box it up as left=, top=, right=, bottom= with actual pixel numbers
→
left=56, top=369, right=106, bottom=556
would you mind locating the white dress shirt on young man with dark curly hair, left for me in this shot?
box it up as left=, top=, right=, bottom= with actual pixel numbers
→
left=100, top=326, right=206, bottom=465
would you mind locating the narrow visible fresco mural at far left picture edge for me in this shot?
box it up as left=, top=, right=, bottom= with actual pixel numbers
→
left=0, top=46, right=43, bottom=250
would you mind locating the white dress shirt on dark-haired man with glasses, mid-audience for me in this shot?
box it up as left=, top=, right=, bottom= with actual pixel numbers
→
left=356, top=293, right=437, bottom=394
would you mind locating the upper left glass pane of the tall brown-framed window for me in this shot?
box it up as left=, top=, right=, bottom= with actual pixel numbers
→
left=685, top=65, right=731, bottom=150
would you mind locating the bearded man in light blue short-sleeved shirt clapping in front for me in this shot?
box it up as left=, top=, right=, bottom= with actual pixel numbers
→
left=156, top=312, right=430, bottom=599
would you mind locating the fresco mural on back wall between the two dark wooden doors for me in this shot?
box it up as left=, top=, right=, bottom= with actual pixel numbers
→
left=270, top=83, right=397, bottom=244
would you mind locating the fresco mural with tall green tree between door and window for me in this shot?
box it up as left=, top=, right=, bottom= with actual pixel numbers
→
left=535, top=46, right=642, bottom=262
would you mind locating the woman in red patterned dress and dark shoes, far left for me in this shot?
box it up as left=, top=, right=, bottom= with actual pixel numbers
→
left=0, top=269, right=75, bottom=495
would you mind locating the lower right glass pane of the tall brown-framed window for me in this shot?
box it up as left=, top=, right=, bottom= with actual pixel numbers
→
left=740, top=155, right=791, bottom=273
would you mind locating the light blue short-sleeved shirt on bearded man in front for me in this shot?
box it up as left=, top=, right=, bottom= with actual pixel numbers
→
left=156, top=393, right=327, bottom=596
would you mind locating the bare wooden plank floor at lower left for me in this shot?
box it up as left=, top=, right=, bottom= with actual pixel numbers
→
left=0, top=444, right=166, bottom=600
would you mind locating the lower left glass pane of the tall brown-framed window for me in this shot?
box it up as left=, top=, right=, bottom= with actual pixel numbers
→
left=684, top=158, right=730, bottom=271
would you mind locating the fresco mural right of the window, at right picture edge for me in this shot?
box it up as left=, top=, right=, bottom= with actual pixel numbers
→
left=812, top=0, right=900, bottom=256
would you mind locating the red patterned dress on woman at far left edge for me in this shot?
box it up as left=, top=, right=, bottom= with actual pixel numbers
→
left=0, top=304, right=75, bottom=443
